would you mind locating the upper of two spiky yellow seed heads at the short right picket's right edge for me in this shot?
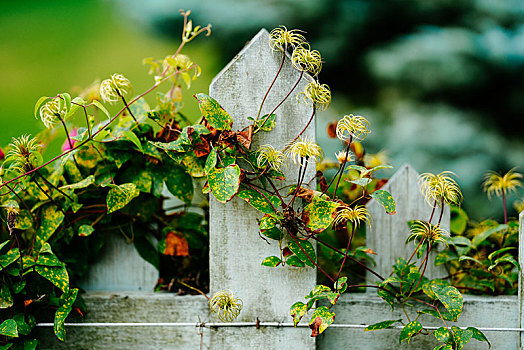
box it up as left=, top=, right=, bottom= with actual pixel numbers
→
left=419, top=171, right=462, bottom=207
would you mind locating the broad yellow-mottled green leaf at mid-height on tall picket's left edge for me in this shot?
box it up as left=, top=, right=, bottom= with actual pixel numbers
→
left=207, top=164, right=240, bottom=203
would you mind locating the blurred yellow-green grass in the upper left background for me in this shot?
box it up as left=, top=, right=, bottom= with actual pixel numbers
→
left=0, top=0, right=219, bottom=154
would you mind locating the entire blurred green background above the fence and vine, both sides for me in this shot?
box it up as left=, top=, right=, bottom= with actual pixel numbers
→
left=0, top=0, right=524, bottom=219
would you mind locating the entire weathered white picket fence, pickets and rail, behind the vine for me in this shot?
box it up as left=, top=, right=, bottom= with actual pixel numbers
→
left=38, top=29, right=524, bottom=350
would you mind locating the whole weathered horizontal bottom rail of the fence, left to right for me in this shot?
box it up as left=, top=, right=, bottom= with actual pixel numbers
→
left=37, top=292, right=519, bottom=350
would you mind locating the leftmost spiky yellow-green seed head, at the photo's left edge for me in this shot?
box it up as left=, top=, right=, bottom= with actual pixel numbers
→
left=6, top=134, right=41, bottom=174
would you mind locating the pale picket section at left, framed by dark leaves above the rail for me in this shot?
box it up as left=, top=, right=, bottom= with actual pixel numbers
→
left=80, top=234, right=158, bottom=292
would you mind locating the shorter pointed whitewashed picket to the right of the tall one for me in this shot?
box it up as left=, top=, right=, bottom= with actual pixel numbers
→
left=366, top=164, right=450, bottom=280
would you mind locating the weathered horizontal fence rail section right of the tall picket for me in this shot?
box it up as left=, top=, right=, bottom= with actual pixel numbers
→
left=317, top=293, right=520, bottom=350
